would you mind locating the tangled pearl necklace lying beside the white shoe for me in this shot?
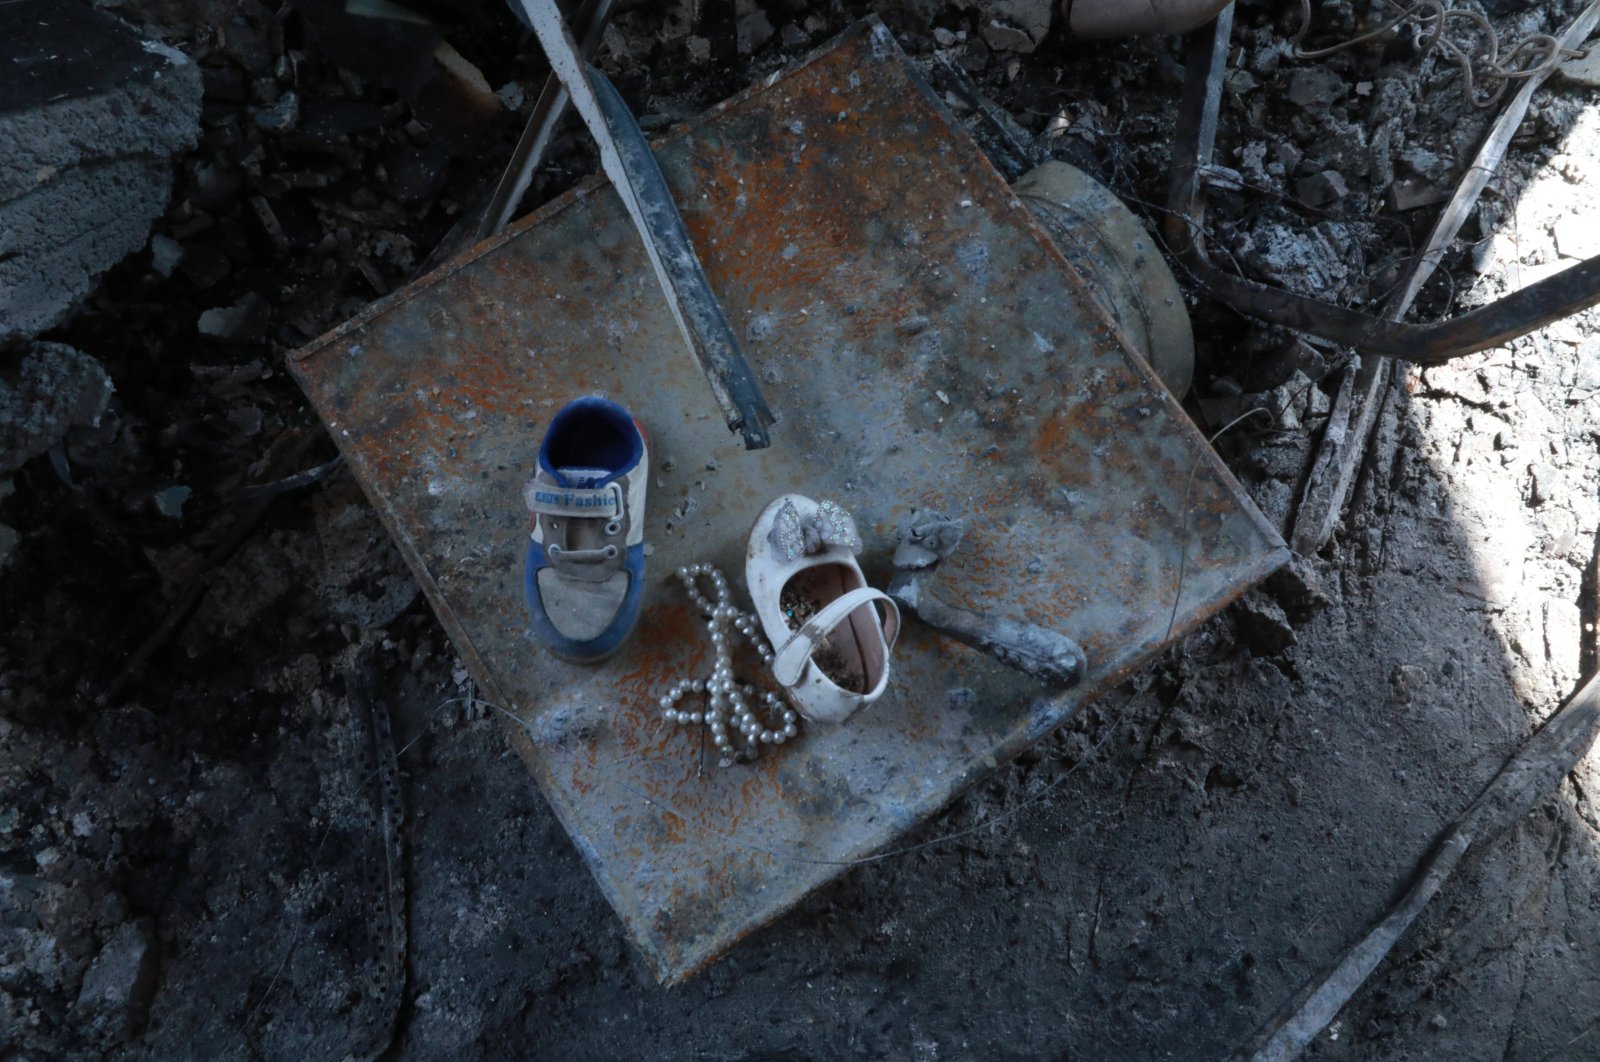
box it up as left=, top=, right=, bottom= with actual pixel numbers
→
left=661, top=565, right=800, bottom=766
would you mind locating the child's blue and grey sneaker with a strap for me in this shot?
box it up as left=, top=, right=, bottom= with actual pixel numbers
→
left=523, top=398, right=650, bottom=664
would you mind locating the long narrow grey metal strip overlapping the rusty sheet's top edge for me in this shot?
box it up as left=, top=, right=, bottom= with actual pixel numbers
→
left=515, top=0, right=776, bottom=449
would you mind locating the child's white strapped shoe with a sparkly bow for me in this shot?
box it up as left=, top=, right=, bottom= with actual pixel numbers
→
left=744, top=494, right=899, bottom=723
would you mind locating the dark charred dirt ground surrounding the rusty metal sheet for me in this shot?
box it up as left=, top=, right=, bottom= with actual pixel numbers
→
left=0, top=0, right=1600, bottom=1062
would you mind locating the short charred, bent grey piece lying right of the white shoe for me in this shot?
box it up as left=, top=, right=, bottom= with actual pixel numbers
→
left=888, top=510, right=1086, bottom=686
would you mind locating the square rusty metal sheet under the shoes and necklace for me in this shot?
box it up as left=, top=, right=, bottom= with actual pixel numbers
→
left=294, top=22, right=1286, bottom=982
